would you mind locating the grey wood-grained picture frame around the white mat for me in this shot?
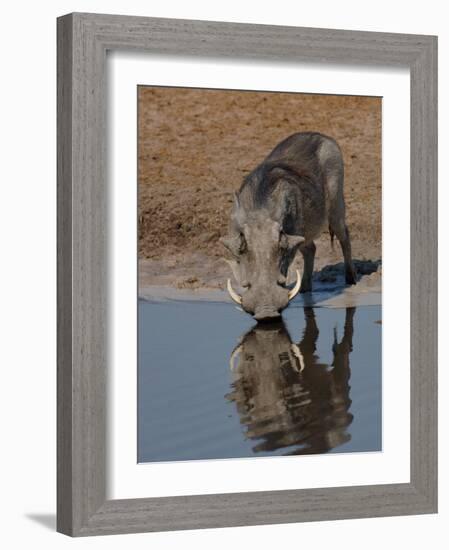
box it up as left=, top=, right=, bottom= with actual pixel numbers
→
left=57, top=13, right=437, bottom=536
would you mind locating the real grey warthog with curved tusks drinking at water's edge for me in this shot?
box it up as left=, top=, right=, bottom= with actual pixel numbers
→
left=221, top=132, right=356, bottom=320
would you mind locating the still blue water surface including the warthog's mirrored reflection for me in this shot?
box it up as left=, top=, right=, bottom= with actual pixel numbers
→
left=138, top=300, right=382, bottom=462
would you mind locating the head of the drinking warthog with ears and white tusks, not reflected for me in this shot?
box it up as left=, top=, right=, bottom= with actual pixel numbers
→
left=221, top=197, right=304, bottom=321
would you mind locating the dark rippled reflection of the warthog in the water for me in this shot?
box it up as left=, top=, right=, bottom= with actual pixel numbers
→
left=226, top=308, right=355, bottom=454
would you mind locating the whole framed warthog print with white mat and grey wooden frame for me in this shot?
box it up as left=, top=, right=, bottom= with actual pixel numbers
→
left=58, top=14, right=437, bottom=536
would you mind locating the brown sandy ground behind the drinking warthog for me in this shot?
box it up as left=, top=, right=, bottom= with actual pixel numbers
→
left=138, top=87, right=381, bottom=295
